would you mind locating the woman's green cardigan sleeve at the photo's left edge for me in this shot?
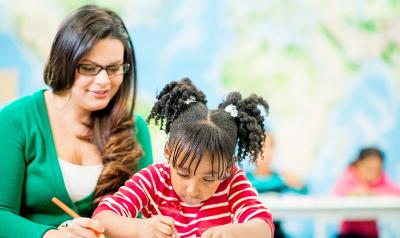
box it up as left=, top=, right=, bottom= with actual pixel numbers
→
left=0, top=105, right=52, bottom=238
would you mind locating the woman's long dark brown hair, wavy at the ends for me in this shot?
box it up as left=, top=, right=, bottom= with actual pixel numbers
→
left=44, top=5, right=143, bottom=204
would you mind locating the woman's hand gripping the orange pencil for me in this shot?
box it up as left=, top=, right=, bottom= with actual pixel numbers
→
left=44, top=217, right=104, bottom=238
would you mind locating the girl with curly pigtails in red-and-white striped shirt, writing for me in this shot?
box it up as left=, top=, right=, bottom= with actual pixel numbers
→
left=94, top=79, right=273, bottom=238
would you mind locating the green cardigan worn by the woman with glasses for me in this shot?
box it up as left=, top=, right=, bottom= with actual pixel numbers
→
left=0, top=90, right=153, bottom=238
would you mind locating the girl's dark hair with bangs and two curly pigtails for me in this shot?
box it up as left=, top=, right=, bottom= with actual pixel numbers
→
left=147, top=78, right=269, bottom=179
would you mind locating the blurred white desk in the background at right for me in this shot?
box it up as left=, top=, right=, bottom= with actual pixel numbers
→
left=260, top=195, right=400, bottom=238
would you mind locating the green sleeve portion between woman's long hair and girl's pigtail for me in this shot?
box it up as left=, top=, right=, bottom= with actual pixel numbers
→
left=135, top=115, right=153, bottom=170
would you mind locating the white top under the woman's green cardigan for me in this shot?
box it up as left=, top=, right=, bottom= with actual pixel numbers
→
left=58, top=159, right=104, bottom=202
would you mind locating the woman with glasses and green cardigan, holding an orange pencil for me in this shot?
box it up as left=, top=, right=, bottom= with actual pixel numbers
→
left=0, top=5, right=152, bottom=238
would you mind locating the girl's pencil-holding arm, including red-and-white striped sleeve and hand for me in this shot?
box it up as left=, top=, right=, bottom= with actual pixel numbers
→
left=93, top=166, right=178, bottom=238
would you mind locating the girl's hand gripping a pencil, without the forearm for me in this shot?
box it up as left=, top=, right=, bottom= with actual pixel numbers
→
left=139, top=215, right=179, bottom=238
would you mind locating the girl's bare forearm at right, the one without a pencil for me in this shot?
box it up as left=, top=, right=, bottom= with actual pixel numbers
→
left=201, top=218, right=272, bottom=238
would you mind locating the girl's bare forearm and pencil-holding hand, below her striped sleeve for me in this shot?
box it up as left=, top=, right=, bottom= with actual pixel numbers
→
left=93, top=211, right=175, bottom=238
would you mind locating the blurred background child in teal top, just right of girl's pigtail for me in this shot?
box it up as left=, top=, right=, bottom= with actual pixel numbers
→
left=246, top=135, right=307, bottom=238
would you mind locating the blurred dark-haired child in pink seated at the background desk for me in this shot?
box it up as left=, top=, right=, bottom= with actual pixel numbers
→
left=334, top=147, right=400, bottom=237
